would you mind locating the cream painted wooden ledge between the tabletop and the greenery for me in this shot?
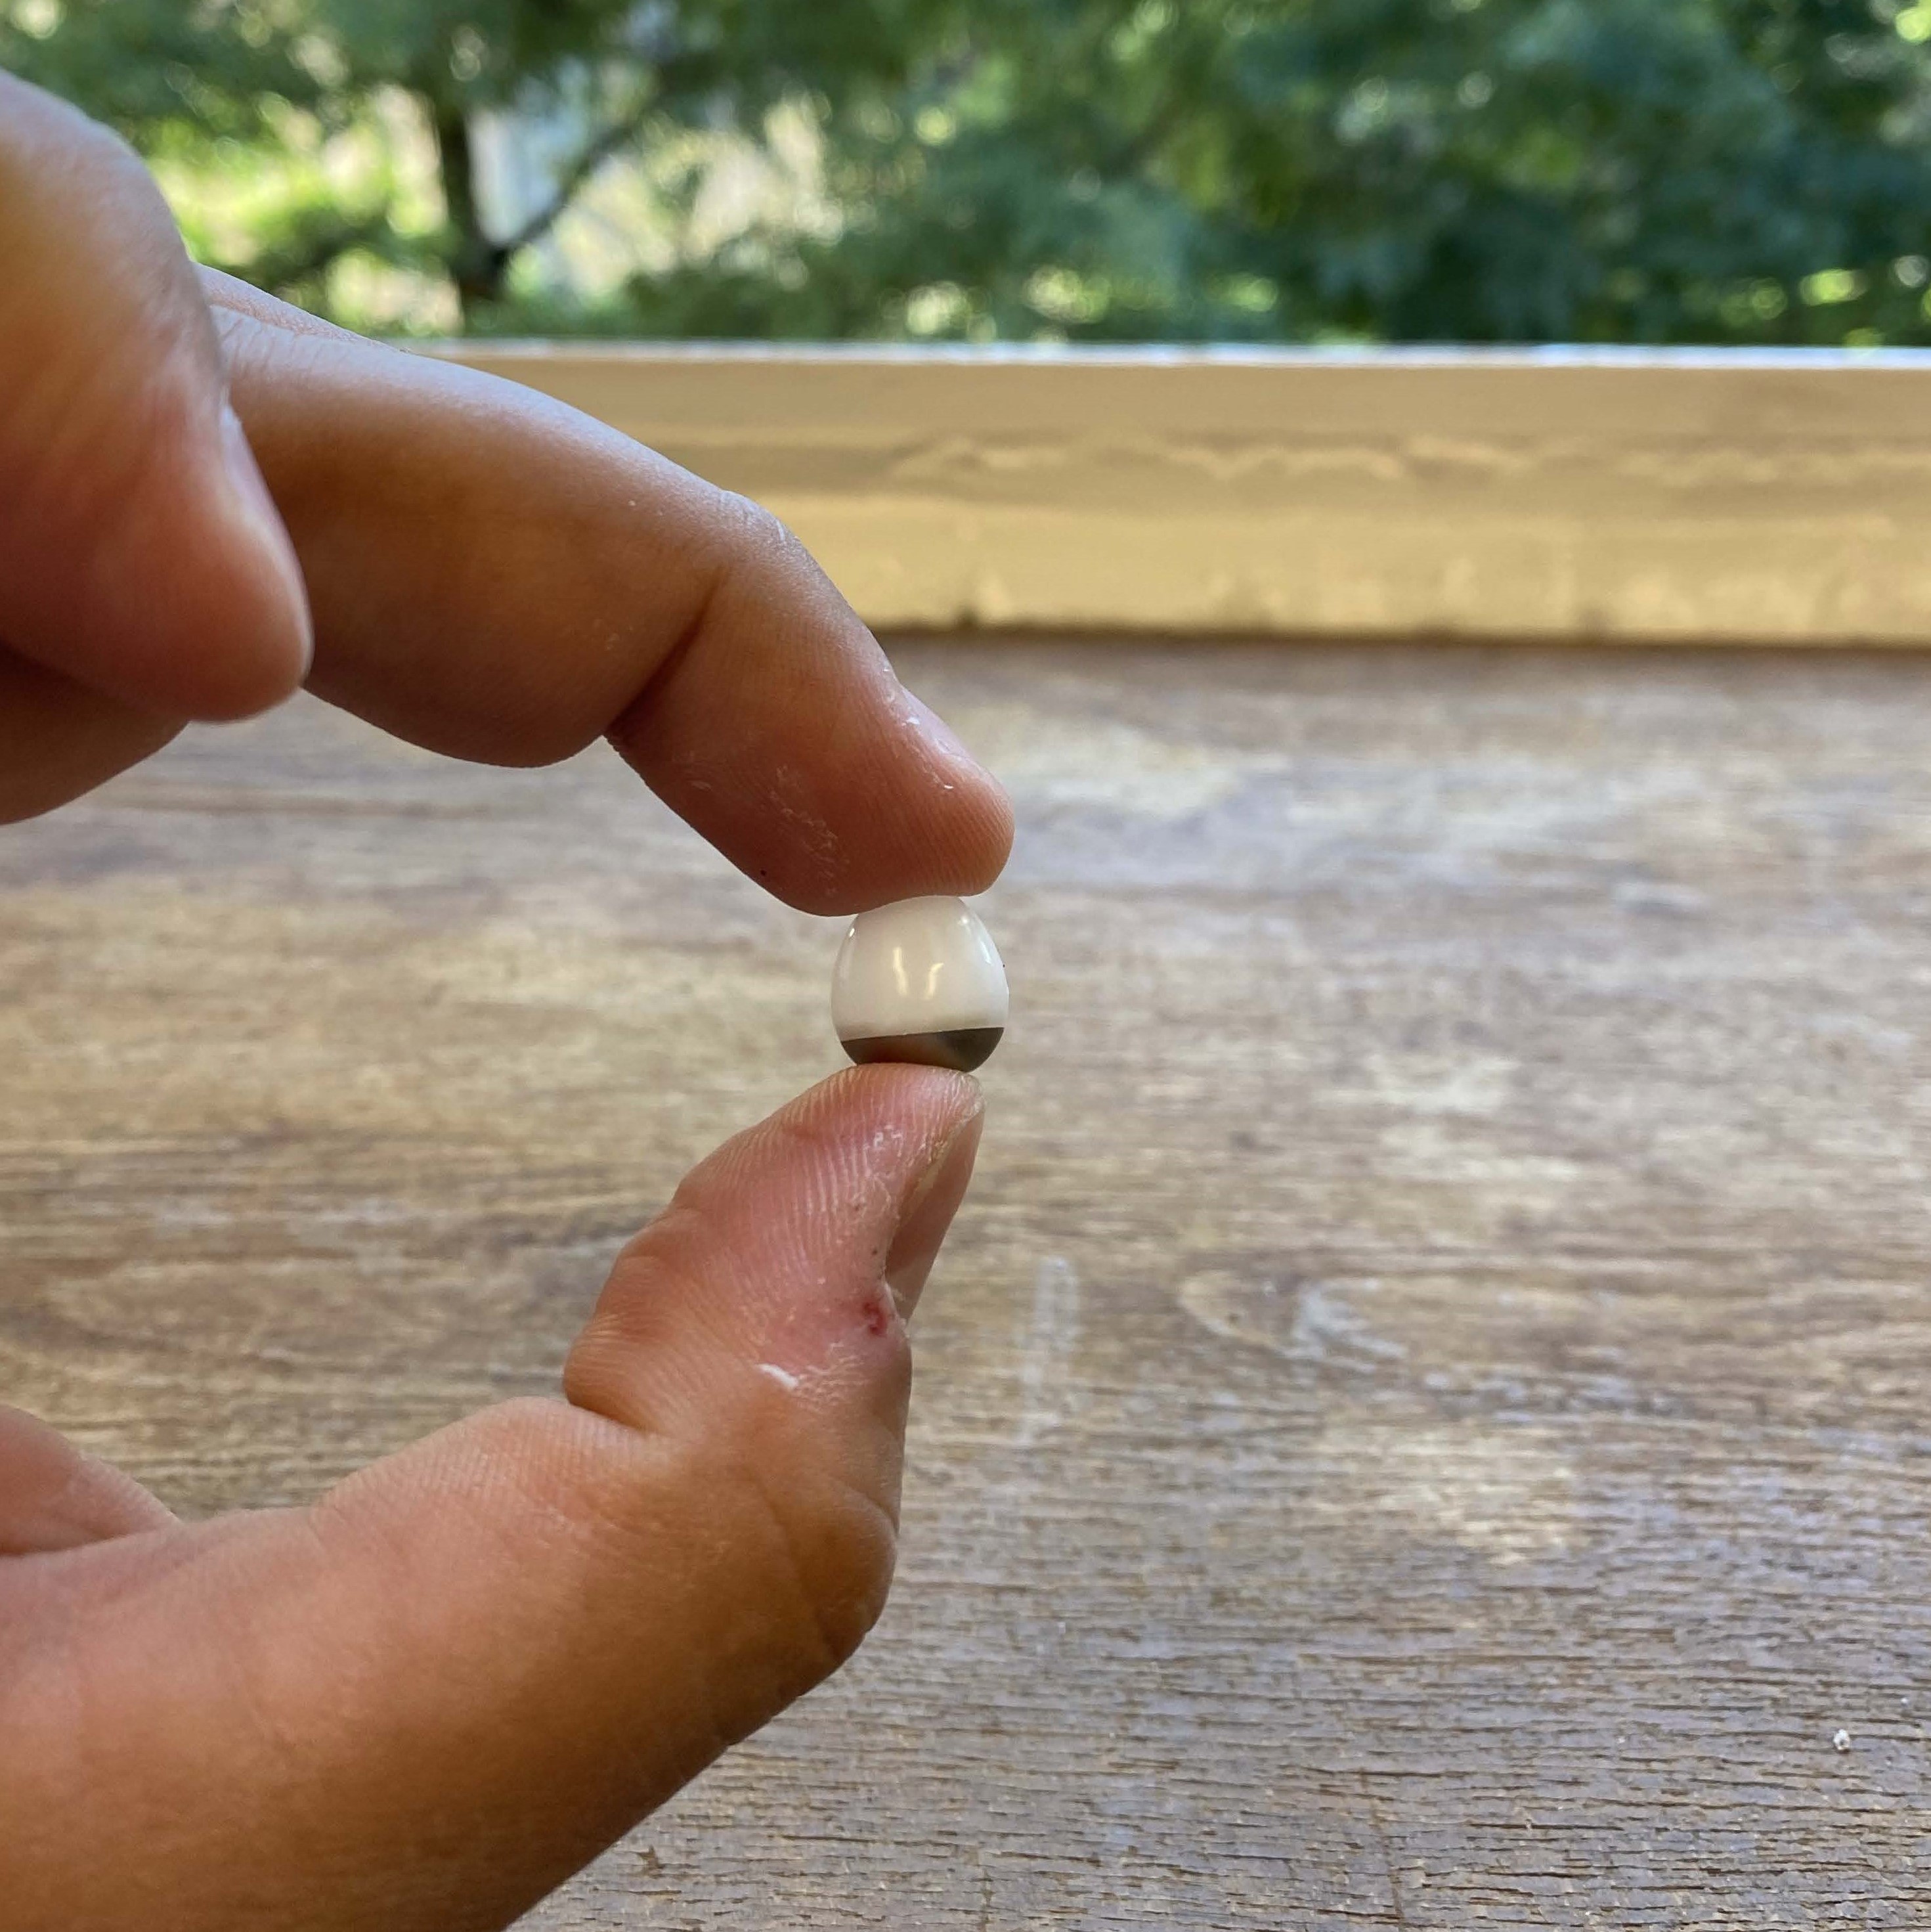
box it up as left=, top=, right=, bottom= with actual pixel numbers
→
left=439, top=344, right=1931, bottom=644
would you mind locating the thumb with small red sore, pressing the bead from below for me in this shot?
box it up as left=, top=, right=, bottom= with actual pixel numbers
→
left=0, top=1066, right=979, bottom=1932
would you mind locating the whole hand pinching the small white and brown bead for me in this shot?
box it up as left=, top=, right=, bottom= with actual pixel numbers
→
left=0, top=76, right=1012, bottom=1932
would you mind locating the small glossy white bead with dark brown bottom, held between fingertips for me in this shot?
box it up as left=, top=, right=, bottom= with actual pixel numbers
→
left=833, top=898, right=1012, bottom=1074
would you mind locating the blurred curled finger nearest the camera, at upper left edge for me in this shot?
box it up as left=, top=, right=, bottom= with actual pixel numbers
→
left=0, top=74, right=309, bottom=718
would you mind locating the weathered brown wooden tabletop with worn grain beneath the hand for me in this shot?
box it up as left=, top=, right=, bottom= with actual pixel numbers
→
left=0, top=642, right=1931, bottom=1932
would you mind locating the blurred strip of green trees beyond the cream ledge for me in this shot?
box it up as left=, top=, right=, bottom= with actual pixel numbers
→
left=11, top=0, right=1931, bottom=346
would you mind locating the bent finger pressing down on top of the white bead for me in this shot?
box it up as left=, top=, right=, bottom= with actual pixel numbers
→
left=205, top=276, right=1012, bottom=912
